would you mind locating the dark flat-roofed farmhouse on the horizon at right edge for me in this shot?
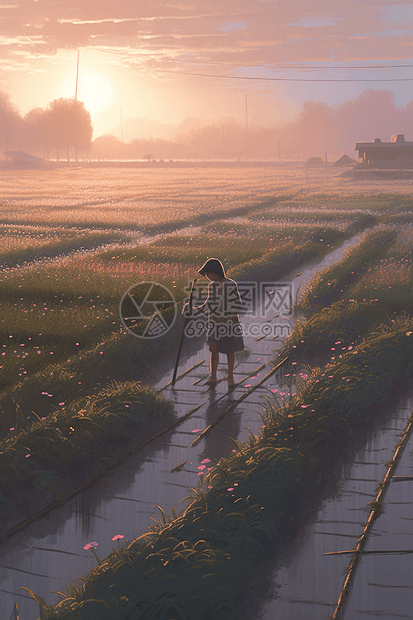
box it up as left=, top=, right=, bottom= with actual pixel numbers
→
left=354, top=134, right=413, bottom=168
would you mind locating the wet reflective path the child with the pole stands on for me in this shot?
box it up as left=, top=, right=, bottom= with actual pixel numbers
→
left=0, top=238, right=366, bottom=620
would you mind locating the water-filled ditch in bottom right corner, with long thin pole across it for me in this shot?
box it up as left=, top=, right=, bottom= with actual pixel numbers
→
left=236, top=382, right=413, bottom=620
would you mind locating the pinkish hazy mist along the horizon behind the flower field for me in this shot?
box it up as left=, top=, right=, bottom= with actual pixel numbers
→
left=0, top=89, right=413, bottom=161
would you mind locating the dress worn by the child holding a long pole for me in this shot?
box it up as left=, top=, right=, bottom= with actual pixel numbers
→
left=205, top=278, right=245, bottom=353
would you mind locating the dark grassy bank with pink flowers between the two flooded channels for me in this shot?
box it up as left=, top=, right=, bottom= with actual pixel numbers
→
left=38, top=321, right=413, bottom=620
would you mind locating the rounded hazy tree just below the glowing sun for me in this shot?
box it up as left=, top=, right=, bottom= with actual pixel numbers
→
left=42, top=97, right=93, bottom=161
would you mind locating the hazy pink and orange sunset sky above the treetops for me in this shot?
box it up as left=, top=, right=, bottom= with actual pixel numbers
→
left=0, top=0, right=413, bottom=136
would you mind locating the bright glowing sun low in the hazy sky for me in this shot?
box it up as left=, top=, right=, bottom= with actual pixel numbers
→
left=59, top=66, right=114, bottom=119
